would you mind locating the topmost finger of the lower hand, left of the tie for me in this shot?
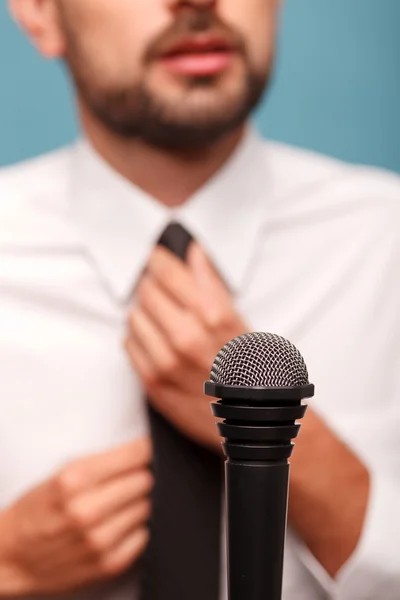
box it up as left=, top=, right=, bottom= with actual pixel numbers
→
left=68, top=470, right=153, bottom=529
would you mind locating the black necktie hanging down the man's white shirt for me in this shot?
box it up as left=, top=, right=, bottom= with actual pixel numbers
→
left=141, top=223, right=223, bottom=600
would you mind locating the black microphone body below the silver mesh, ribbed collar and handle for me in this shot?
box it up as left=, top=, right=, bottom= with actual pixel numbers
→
left=205, top=381, right=314, bottom=600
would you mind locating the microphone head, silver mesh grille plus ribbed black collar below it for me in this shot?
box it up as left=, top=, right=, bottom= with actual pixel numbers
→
left=208, top=333, right=314, bottom=461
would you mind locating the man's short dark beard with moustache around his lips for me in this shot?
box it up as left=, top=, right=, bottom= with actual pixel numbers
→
left=63, top=9, right=270, bottom=150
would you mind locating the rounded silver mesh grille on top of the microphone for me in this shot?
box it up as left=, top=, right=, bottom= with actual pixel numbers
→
left=210, top=333, right=309, bottom=387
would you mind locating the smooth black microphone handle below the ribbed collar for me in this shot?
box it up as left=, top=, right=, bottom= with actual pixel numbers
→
left=225, top=459, right=289, bottom=600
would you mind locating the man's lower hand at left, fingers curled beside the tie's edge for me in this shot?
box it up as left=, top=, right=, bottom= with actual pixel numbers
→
left=0, top=439, right=152, bottom=597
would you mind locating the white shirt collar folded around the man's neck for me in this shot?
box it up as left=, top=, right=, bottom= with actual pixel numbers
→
left=70, top=127, right=268, bottom=301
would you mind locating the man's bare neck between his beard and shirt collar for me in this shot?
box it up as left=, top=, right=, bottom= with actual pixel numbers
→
left=81, top=107, right=245, bottom=207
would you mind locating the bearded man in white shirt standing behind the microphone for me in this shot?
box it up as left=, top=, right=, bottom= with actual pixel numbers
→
left=0, top=0, right=400, bottom=600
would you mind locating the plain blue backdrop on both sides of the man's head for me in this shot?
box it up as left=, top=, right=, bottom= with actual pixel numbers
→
left=0, top=0, right=400, bottom=172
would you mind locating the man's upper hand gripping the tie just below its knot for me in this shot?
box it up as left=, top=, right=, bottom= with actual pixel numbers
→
left=126, top=243, right=246, bottom=451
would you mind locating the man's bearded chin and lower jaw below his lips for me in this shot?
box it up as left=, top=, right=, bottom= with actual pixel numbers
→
left=82, top=64, right=266, bottom=150
